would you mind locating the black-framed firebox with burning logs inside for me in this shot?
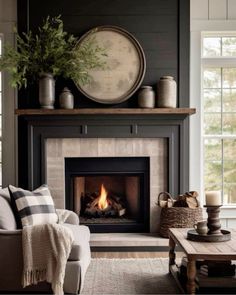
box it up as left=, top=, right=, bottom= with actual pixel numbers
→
left=65, top=157, right=150, bottom=232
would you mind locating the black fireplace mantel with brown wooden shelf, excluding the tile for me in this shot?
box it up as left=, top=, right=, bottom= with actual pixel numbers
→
left=16, top=108, right=195, bottom=195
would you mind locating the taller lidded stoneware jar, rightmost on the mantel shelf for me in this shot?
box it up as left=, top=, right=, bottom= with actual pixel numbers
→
left=157, top=76, right=177, bottom=108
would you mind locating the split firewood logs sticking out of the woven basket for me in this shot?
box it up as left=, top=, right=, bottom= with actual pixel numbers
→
left=158, top=191, right=199, bottom=209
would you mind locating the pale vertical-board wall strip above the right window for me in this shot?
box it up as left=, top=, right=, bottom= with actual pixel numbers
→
left=190, top=0, right=236, bottom=20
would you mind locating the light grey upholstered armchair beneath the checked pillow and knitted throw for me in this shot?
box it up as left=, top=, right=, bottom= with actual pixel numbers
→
left=0, top=189, right=91, bottom=294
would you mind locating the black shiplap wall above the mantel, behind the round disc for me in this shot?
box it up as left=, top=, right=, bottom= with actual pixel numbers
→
left=18, top=0, right=189, bottom=108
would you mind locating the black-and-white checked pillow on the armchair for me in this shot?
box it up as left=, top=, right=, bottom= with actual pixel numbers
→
left=9, top=184, right=58, bottom=227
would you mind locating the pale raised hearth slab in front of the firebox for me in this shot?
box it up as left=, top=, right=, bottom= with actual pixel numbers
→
left=90, top=233, right=169, bottom=247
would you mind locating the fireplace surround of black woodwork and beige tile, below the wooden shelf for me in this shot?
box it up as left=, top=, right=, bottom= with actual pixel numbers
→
left=19, top=112, right=189, bottom=244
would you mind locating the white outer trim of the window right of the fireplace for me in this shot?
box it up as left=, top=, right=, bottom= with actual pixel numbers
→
left=189, top=20, right=236, bottom=219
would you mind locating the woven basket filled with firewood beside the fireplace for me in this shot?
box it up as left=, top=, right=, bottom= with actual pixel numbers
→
left=157, top=191, right=203, bottom=238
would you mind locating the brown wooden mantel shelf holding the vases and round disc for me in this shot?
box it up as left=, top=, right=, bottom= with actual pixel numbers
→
left=15, top=108, right=196, bottom=115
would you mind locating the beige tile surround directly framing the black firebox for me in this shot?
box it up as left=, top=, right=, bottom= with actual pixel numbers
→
left=46, top=138, right=168, bottom=232
